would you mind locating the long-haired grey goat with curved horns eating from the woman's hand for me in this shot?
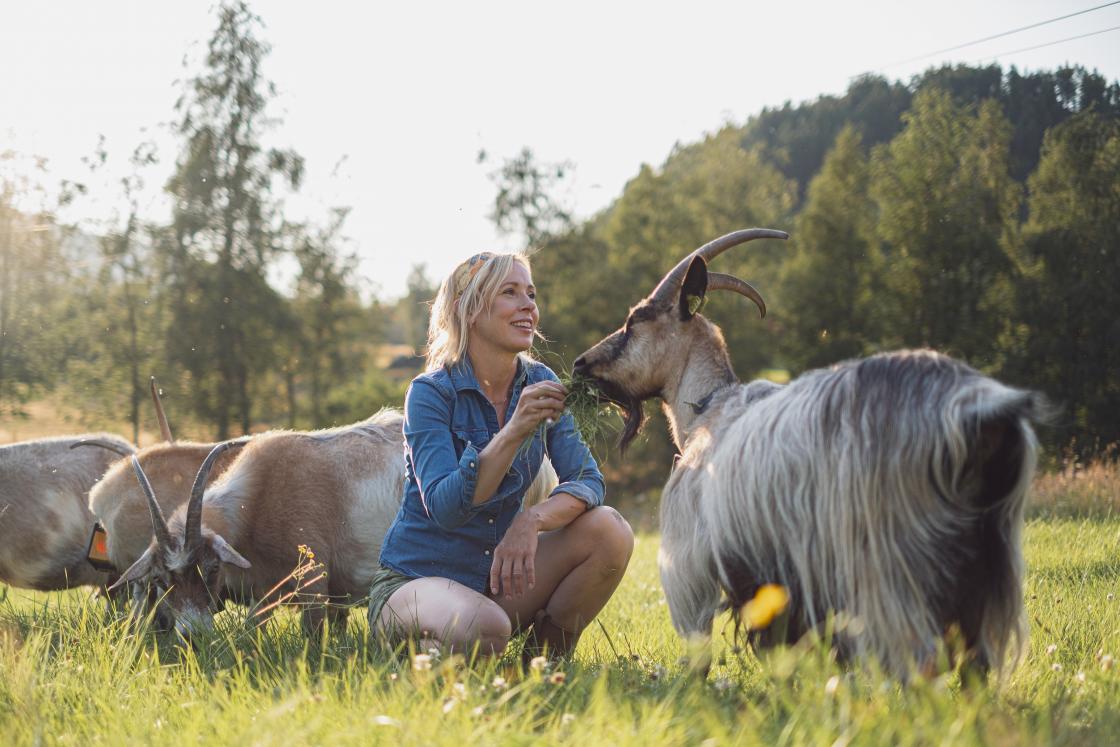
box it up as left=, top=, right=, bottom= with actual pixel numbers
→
left=575, top=228, right=1044, bottom=679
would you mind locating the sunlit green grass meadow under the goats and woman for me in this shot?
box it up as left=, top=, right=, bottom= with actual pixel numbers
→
left=0, top=465, right=1120, bottom=746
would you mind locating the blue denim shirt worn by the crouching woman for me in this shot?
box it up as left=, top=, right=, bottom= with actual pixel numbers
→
left=381, top=357, right=604, bottom=594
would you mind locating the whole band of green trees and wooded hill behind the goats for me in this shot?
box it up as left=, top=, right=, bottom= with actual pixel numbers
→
left=0, top=2, right=1120, bottom=501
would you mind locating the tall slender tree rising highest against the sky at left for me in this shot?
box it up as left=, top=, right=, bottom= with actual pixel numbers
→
left=167, top=1, right=304, bottom=439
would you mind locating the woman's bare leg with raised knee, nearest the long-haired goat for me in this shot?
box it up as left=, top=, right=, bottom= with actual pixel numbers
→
left=494, top=506, right=634, bottom=654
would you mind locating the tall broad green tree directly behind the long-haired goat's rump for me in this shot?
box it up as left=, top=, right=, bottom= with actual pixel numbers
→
left=871, top=88, right=1021, bottom=366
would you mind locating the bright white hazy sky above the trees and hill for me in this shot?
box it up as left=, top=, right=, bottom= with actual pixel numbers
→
left=0, top=0, right=1120, bottom=298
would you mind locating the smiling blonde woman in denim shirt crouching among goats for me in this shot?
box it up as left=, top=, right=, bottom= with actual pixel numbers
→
left=370, top=252, right=634, bottom=656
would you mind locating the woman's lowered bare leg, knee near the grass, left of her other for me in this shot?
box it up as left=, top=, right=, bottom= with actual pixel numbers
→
left=377, top=578, right=511, bottom=655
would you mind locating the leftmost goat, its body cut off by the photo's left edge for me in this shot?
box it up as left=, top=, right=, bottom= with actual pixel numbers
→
left=0, top=433, right=133, bottom=591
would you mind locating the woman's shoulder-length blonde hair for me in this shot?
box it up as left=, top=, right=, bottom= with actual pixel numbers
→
left=426, top=253, right=530, bottom=371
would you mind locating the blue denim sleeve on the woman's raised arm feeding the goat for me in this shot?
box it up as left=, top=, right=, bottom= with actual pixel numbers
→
left=404, top=380, right=478, bottom=529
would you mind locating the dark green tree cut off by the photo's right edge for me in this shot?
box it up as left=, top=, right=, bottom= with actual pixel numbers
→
left=1008, top=111, right=1120, bottom=454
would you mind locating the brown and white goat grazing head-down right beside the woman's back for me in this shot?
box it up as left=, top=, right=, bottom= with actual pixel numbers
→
left=118, top=410, right=404, bottom=636
